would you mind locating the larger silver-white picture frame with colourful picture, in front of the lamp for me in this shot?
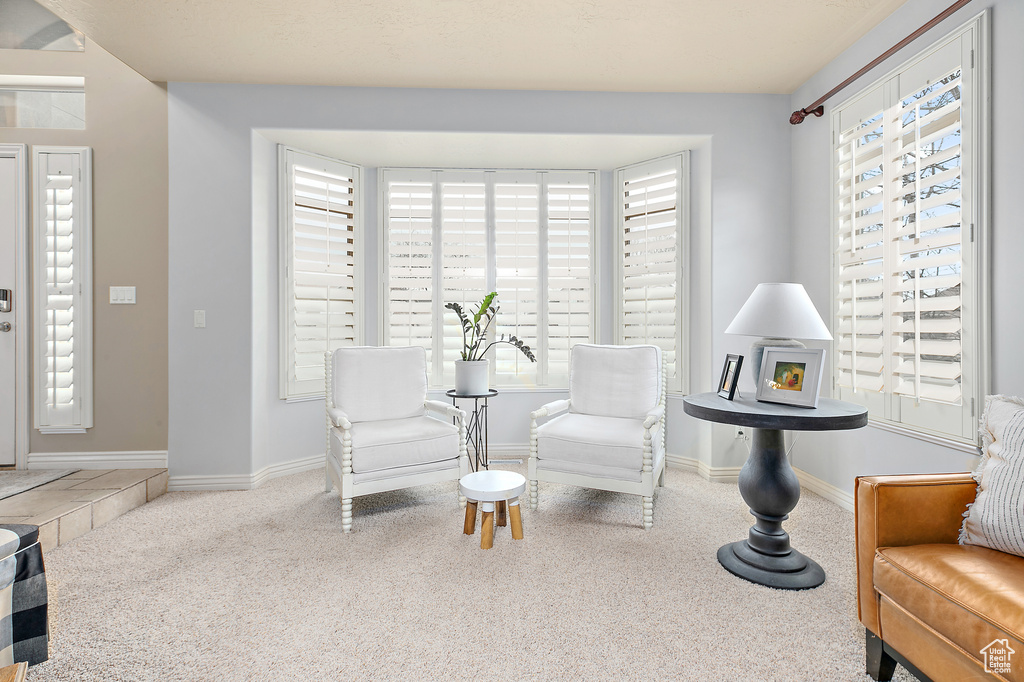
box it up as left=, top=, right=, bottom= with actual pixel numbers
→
left=755, top=346, right=825, bottom=408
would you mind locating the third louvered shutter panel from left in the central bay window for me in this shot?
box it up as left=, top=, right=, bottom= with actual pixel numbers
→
left=488, top=173, right=544, bottom=385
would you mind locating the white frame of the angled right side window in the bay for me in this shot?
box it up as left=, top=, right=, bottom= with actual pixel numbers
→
left=612, top=150, right=690, bottom=395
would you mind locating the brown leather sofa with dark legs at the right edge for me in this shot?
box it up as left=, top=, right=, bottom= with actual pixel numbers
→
left=855, top=473, right=1024, bottom=682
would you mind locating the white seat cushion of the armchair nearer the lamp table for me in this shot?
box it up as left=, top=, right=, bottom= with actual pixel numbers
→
left=537, top=414, right=662, bottom=472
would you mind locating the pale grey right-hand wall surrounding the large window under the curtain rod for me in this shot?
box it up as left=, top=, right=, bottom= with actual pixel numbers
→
left=791, top=0, right=1024, bottom=493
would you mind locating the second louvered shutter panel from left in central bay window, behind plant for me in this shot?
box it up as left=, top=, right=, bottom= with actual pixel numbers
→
left=435, top=178, right=493, bottom=386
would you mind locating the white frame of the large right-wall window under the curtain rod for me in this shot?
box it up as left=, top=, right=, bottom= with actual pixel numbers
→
left=829, top=10, right=991, bottom=446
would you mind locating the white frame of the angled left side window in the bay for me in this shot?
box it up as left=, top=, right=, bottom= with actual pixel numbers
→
left=278, top=144, right=366, bottom=402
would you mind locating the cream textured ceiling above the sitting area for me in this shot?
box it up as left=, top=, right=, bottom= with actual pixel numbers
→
left=40, top=0, right=904, bottom=94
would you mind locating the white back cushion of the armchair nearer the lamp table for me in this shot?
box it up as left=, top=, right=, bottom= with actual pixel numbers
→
left=569, top=343, right=662, bottom=419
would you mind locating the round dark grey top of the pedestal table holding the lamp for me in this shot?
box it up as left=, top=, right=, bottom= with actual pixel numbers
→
left=683, top=393, right=867, bottom=431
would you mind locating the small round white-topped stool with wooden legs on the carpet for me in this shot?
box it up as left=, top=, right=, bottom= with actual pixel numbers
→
left=459, top=471, right=526, bottom=549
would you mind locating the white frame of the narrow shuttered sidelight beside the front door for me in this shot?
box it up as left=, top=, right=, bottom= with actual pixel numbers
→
left=32, top=145, right=94, bottom=434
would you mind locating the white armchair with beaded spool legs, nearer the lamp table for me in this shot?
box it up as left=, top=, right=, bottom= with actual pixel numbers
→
left=528, top=344, right=665, bottom=529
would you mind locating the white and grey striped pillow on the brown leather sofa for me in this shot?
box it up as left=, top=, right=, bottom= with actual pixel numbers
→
left=959, top=395, right=1024, bottom=556
